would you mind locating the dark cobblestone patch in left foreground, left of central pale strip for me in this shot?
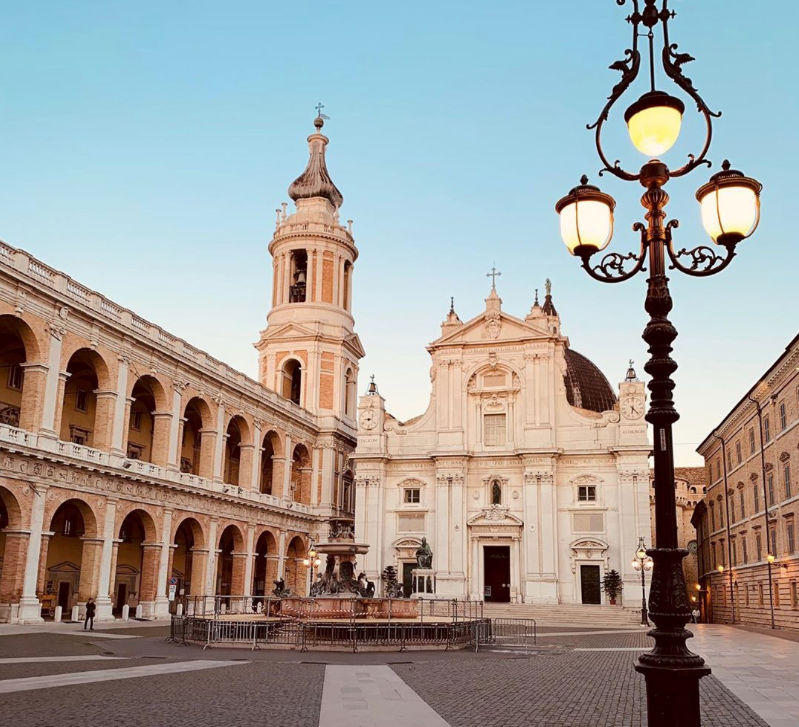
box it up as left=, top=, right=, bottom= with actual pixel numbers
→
left=0, top=662, right=325, bottom=727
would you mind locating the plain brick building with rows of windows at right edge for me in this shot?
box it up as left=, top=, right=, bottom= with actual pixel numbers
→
left=693, top=336, right=799, bottom=629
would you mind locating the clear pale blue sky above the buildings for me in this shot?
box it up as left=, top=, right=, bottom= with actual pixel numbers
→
left=0, top=0, right=799, bottom=464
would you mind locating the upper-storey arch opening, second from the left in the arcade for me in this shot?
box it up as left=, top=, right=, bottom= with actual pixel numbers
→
left=56, top=348, right=116, bottom=449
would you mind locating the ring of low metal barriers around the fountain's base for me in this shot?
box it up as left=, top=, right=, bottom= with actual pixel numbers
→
left=168, top=616, right=490, bottom=652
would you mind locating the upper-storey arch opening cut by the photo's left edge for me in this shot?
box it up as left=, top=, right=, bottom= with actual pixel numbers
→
left=0, top=315, right=46, bottom=430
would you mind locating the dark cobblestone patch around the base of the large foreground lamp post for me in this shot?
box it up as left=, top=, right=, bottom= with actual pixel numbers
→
left=392, top=656, right=767, bottom=727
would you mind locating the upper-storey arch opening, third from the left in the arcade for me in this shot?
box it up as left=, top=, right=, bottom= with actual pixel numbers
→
left=125, top=374, right=172, bottom=466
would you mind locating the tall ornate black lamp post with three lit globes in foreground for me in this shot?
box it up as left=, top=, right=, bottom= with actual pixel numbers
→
left=555, top=5, right=761, bottom=727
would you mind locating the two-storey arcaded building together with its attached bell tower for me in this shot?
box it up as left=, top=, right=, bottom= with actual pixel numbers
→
left=0, top=118, right=363, bottom=622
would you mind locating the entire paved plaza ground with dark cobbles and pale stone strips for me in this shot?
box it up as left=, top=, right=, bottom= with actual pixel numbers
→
left=0, top=623, right=799, bottom=727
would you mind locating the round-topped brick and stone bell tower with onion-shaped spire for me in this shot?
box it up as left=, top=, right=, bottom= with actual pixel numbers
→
left=255, top=116, right=364, bottom=431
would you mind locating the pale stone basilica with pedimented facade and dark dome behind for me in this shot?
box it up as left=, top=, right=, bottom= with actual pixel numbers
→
left=354, top=288, right=651, bottom=606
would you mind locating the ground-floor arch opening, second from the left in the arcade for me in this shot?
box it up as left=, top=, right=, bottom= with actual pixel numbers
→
left=45, top=493, right=102, bottom=613
